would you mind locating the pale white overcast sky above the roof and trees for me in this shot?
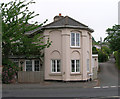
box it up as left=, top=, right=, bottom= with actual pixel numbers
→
left=0, top=0, right=119, bottom=41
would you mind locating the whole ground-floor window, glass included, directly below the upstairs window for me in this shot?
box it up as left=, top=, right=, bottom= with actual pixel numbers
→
left=71, top=60, right=80, bottom=73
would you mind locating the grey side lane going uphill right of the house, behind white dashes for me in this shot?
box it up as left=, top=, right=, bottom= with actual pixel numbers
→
left=98, top=58, right=120, bottom=86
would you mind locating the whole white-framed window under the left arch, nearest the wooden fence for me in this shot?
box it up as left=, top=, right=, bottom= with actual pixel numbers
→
left=51, top=60, right=60, bottom=73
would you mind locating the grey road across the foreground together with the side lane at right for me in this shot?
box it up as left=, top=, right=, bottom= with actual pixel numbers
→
left=3, top=58, right=120, bottom=99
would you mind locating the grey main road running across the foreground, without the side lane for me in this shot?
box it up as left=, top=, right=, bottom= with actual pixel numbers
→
left=3, top=88, right=118, bottom=98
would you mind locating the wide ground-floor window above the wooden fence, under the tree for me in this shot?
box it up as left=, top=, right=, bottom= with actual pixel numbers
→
left=25, top=60, right=40, bottom=71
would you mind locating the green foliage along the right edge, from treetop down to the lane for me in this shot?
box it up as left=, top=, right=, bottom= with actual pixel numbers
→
left=105, top=25, right=120, bottom=68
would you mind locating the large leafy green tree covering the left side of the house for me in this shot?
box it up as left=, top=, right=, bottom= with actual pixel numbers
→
left=0, top=0, right=51, bottom=59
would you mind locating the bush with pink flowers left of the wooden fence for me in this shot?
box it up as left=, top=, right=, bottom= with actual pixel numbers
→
left=2, top=59, right=19, bottom=84
